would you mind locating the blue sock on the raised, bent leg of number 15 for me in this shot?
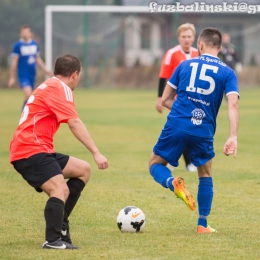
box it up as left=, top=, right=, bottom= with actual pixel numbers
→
left=150, top=163, right=174, bottom=191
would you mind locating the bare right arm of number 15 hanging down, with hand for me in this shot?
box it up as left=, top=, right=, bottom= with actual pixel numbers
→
left=223, top=93, right=239, bottom=157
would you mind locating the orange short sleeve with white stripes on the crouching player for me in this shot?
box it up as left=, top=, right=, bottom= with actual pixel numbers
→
left=46, top=86, right=79, bottom=123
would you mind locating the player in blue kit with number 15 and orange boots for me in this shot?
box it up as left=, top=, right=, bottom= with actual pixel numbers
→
left=149, top=28, right=239, bottom=233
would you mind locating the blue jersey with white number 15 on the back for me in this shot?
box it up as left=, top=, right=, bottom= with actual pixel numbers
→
left=168, top=54, right=239, bottom=137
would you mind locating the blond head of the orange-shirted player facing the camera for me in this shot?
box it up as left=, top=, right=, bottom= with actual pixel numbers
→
left=177, top=23, right=196, bottom=51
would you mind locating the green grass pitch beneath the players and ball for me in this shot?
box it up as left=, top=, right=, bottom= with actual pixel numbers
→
left=0, top=88, right=260, bottom=260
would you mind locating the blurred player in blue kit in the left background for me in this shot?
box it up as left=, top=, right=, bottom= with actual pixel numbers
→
left=8, top=25, right=52, bottom=108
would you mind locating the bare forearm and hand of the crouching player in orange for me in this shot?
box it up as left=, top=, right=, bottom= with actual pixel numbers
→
left=67, top=118, right=108, bottom=169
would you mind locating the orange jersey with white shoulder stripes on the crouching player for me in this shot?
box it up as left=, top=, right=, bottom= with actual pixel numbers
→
left=10, top=77, right=79, bottom=162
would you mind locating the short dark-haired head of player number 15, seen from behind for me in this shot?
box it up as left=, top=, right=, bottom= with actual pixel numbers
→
left=197, top=27, right=222, bottom=55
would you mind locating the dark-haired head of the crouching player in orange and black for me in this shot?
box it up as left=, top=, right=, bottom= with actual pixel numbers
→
left=54, top=54, right=81, bottom=90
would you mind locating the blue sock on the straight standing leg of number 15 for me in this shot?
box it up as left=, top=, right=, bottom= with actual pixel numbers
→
left=197, top=177, right=213, bottom=227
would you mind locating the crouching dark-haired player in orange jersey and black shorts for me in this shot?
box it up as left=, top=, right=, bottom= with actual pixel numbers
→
left=10, top=55, right=108, bottom=249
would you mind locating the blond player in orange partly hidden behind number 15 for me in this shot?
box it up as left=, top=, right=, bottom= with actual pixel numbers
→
left=156, top=23, right=198, bottom=172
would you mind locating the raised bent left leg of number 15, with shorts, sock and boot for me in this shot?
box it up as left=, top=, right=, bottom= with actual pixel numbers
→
left=149, top=124, right=196, bottom=210
